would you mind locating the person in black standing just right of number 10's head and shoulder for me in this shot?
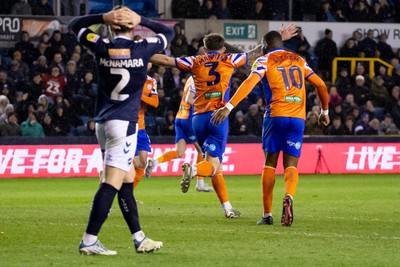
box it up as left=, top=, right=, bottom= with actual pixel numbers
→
left=315, top=29, right=338, bottom=80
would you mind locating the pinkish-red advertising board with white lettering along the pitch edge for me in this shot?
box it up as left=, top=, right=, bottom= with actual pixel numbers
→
left=0, top=143, right=400, bottom=178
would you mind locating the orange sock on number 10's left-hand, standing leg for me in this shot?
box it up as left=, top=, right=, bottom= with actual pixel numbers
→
left=261, top=166, right=275, bottom=214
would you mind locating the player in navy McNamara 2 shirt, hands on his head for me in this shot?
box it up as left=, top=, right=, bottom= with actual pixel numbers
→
left=70, top=7, right=174, bottom=255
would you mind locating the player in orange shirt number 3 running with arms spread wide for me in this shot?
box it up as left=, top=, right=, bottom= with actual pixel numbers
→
left=150, top=25, right=297, bottom=218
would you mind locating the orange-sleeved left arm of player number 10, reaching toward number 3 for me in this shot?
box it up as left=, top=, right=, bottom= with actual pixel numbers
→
left=211, top=73, right=261, bottom=125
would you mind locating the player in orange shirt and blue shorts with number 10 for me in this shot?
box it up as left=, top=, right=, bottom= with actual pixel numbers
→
left=211, top=31, right=329, bottom=226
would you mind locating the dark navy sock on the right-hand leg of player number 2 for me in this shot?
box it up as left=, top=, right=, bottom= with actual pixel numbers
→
left=118, top=183, right=141, bottom=234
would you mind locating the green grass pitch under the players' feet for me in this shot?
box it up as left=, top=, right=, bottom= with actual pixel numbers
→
left=0, top=174, right=400, bottom=267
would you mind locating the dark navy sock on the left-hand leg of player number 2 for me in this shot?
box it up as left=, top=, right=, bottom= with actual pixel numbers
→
left=86, top=183, right=118, bottom=236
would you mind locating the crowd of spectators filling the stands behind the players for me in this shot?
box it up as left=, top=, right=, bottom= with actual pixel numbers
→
left=0, top=0, right=400, bottom=136
